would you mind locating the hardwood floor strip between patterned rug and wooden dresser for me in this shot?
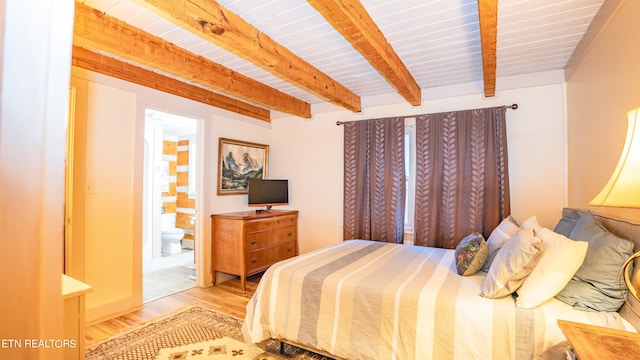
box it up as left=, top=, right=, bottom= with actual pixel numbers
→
left=85, top=273, right=262, bottom=346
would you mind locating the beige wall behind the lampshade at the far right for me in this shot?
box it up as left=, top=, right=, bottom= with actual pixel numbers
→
left=567, top=1, right=640, bottom=222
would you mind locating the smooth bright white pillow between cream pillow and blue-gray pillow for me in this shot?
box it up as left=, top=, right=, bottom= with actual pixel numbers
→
left=516, top=228, right=588, bottom=309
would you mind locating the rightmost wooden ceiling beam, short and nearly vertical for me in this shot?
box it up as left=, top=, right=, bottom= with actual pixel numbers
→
left=478, top=0, right=498, bottom=97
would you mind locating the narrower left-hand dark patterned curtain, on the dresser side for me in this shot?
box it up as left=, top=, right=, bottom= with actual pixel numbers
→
left=343, top=118, right=406, bottom=243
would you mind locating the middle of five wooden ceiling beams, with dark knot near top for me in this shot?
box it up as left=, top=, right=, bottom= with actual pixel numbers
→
left=145, top=0, right=361, bottom=112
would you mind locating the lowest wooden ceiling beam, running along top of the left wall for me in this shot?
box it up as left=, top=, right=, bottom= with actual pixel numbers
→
left=71, top=46, right=271, bottom=122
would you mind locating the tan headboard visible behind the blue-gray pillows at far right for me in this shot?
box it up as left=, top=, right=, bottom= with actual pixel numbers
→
left=562, top=208, right=640, bottom=331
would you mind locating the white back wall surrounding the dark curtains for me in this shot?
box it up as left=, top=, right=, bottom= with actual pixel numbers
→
left=271, top=81, right=566, bottom=253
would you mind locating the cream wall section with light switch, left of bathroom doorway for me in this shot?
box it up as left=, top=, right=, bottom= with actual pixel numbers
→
left=82, top=83, right=136, bottom=319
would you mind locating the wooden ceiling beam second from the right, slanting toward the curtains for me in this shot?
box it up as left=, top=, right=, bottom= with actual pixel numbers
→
left=307, top=0, right=421, bottom=106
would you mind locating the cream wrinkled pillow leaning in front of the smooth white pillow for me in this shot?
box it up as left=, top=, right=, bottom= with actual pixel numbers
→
left=480, top=229, right=544, bottom=299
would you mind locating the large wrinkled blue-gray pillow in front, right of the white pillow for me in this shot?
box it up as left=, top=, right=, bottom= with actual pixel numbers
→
left=556, top=211, right=633, bottom=311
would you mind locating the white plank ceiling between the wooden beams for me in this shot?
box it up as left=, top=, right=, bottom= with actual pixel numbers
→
left=74, top=0, right=604, bottom=116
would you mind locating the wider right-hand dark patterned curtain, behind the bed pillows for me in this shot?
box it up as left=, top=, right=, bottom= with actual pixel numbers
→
left=414, top=107, right=511, bottom=249
